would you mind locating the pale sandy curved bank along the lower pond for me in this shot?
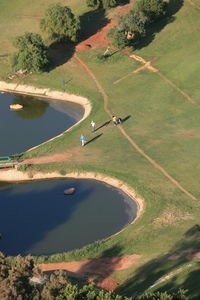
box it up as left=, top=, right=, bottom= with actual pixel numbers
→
left=0, top=169, right=145, bottom=227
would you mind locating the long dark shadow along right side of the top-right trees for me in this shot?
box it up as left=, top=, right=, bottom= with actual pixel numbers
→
left=132, top=0, right=183, bottom=50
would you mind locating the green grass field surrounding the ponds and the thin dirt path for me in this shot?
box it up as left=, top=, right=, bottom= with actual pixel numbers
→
left=0, top=0, right=200, bottom=300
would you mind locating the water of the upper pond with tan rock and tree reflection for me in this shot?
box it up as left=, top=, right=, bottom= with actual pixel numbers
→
left=0, top=94, right=84, bottom=156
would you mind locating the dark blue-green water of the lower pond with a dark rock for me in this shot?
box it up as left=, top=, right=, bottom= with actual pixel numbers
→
left=0, top=180, right=137, bottom=255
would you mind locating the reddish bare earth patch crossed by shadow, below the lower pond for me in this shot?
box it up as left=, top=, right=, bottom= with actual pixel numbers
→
left=39, top=254, right=141, bottom=290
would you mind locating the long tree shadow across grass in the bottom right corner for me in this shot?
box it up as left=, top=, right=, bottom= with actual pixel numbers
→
left=117, top=227, right=200, bottom=295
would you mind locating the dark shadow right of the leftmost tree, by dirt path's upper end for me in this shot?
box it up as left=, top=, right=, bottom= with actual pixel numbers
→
left=47, top=42, right=75, bottom=72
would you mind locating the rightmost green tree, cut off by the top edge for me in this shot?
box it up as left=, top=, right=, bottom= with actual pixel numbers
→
left=136, top=0, right=165, bottom=21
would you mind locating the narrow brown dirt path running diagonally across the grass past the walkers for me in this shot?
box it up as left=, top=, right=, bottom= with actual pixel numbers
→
left=75, top=54, right=197, bottom=200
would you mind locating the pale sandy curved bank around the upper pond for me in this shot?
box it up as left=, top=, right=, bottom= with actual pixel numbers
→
left=0, top=81, right=92, bottom=152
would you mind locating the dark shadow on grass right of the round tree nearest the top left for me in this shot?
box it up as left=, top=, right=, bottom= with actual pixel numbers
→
left=79, top=9, right=109, bottom=42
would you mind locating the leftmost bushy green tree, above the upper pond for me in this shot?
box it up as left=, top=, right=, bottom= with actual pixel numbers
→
left=12, top=32, right=49, bottom=72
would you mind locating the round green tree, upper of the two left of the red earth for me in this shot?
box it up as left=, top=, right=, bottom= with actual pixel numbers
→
left=40, top=4, right=80, bottom=42
